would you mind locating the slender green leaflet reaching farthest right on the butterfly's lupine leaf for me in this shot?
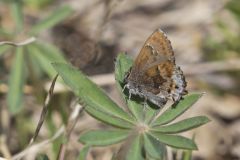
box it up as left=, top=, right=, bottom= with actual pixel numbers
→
left=152, top=116, right=210, bottom=134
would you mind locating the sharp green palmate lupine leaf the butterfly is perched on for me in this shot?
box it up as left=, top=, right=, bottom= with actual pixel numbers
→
left=53, top=54, right=209, bottom=160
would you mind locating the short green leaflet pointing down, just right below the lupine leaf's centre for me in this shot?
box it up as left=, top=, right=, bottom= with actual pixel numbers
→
left=144, top=134, right=167, bottom=160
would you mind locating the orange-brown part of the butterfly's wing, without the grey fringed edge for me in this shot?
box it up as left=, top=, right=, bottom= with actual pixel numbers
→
left=130, top=30, right=175, bottom=96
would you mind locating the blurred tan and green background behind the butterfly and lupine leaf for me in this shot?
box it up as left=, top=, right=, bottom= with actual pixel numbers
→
left=0, top=0, right=240, bottom=160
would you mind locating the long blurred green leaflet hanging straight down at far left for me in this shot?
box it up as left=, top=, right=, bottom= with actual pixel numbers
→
left=7, top=47, right=25, bottom=113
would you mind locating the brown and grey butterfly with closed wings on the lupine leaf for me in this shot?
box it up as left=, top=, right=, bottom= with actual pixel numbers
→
left=124, top=29, right=187, bottom=108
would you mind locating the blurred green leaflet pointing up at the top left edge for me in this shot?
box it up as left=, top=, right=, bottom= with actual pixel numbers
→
left=11, top=0, right=23, bottom=33
